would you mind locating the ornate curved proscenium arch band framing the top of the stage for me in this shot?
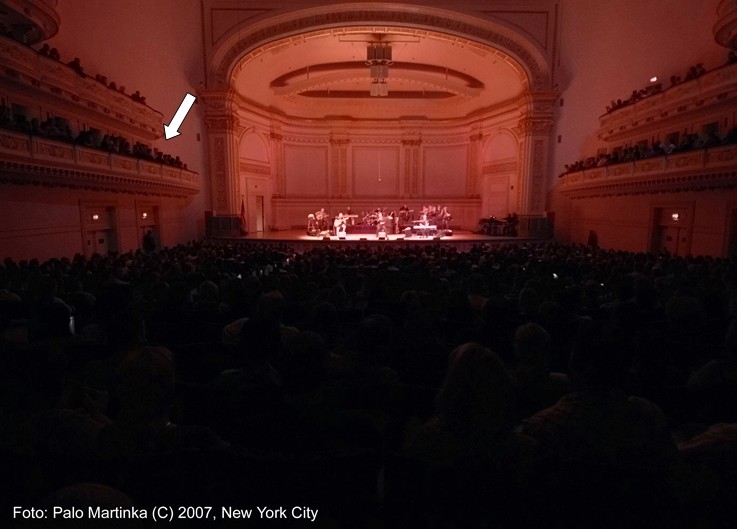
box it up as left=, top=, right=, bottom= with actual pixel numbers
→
left=207, top=3, right=551, bottom=92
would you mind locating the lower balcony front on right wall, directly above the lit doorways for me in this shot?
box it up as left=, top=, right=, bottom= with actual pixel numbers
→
left=560, top=144, right=737, bottom=198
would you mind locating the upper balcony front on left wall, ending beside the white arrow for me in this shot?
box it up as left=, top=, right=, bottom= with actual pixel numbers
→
left=0, top=37, right=164, bottom=142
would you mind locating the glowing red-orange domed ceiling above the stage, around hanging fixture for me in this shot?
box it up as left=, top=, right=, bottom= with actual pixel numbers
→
left=231, top=27, right=527, bottom=119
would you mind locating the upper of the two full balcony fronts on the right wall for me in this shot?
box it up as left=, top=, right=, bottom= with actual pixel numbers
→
left=598, top=63, right=737, bottom=142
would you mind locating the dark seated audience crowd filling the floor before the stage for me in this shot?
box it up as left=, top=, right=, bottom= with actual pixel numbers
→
left=0, top=237, right=737, bottom=529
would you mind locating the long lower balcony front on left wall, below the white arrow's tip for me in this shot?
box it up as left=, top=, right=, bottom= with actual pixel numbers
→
left=0, top=130, right=200, bottom=197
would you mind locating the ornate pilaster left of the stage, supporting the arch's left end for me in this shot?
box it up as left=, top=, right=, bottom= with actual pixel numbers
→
left=199, top=90, right=240, bottom=215
